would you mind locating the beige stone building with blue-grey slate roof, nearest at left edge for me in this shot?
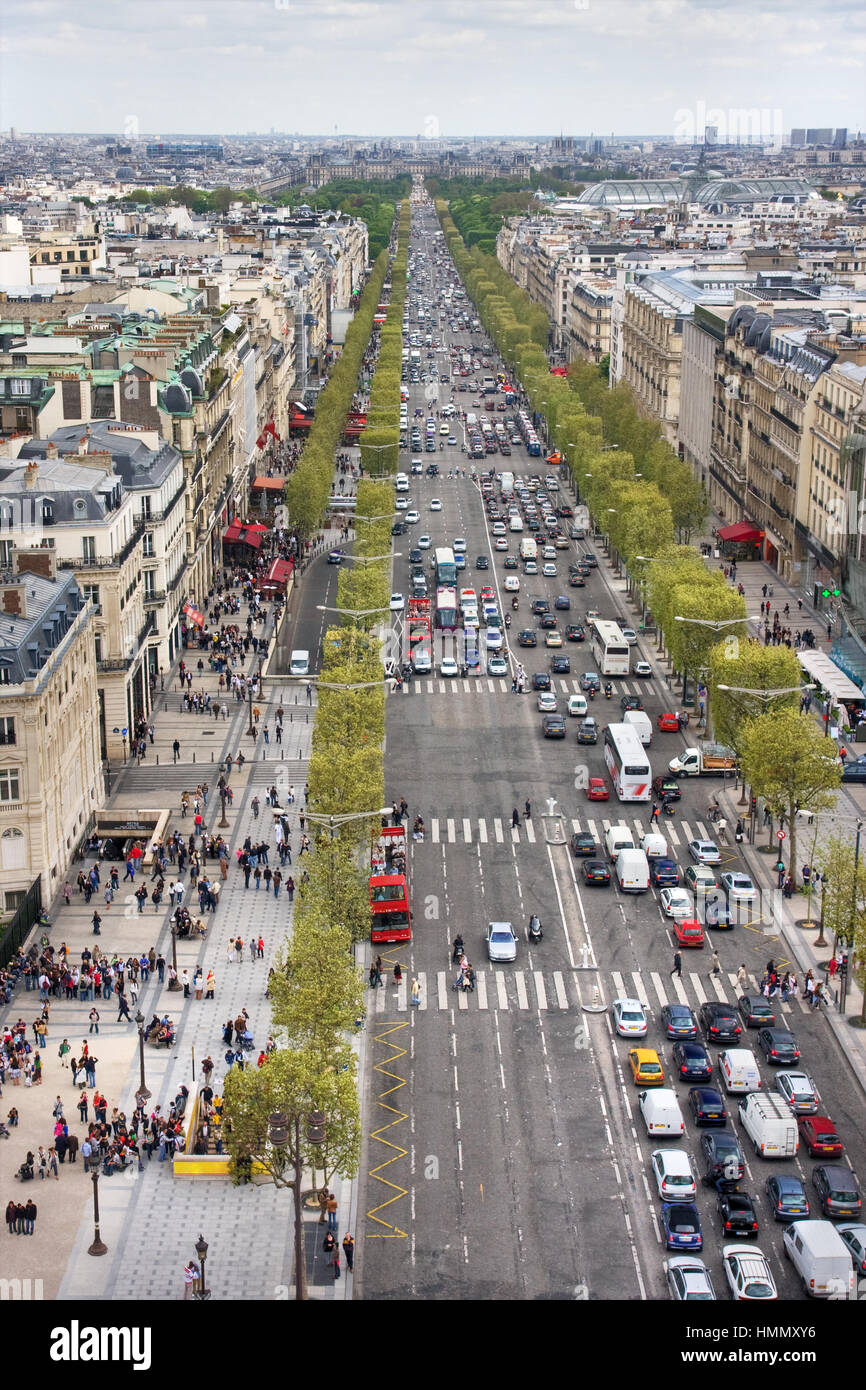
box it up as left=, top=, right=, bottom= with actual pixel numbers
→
left=0, top=548, right=103, bottom=916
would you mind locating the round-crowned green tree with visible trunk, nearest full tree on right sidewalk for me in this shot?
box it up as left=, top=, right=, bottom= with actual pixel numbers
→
left=740, top=709, right=841, bottom=878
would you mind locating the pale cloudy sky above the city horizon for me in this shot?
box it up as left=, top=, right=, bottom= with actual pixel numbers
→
left=0, top=0, right=866, bottom=138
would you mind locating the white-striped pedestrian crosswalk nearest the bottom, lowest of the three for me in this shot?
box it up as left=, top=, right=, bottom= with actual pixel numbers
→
left=367, top=966, right=809, bottom=1017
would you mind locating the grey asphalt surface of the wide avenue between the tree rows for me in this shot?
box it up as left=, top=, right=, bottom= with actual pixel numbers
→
left=354, top=205, right=866, bottom=1300
